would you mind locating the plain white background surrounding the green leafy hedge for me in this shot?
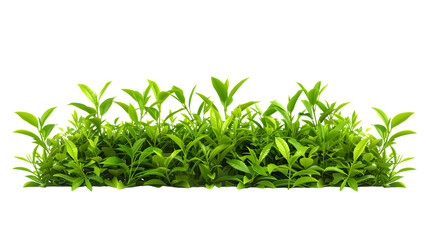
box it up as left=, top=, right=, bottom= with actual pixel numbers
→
left=0, top=0, right=429, bottom=239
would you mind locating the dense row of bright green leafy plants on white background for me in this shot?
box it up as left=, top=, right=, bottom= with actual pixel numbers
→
left=15, top=78, right=415, bottom=191
